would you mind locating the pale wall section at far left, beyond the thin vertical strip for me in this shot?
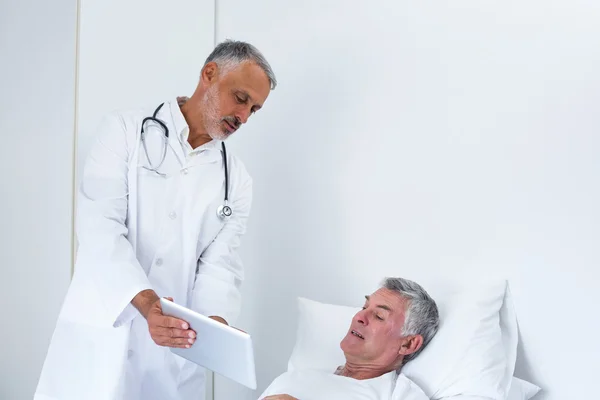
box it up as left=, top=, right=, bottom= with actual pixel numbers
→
left=0, top=0, right=77, bottom=400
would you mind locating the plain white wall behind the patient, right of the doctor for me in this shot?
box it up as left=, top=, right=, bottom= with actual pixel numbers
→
left=216, top=0, right=600, bottom=400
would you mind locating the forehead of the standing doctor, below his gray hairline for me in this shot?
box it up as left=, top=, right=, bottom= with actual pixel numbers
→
left=223, top=62, right=271, bottom=105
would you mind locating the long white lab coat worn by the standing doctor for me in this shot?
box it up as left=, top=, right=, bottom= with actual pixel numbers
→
left=34, top=100, right=252, bottom=400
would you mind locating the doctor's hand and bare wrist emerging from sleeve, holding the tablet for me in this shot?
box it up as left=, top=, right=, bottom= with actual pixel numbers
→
left=132, top=290, right=196, bottom=348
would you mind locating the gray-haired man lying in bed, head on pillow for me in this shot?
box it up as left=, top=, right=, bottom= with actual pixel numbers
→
left=260, top=278, right=439, bottom=400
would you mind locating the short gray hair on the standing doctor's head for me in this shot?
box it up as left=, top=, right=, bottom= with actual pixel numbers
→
left=204, top=40, right=277, bottom=90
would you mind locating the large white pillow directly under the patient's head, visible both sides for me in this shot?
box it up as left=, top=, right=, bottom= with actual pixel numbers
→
left=288, top=281, right=518, bottom=400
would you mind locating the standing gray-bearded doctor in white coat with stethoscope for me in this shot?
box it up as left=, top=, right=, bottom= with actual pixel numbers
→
left=34, top=41, right=276, bottom=400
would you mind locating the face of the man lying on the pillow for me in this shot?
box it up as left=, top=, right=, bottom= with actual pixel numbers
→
left=340, top=288, right=408, bottom=368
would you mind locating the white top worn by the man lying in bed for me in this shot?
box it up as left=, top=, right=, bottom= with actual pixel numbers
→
left=258, top=370, right=428, bottom=400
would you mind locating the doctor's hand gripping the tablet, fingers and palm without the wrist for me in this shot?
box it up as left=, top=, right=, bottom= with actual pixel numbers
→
left=146, top=297, right=196, bottom=349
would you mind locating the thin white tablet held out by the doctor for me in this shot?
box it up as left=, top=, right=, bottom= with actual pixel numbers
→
left=160, top=298, right=256, bottom=389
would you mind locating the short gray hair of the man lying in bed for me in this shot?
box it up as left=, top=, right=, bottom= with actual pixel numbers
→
left=382, top=278, right=440, bottom=364
